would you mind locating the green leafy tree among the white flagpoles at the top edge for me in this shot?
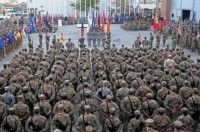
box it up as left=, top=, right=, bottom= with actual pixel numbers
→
left=71, top=0, right=100, bottom=11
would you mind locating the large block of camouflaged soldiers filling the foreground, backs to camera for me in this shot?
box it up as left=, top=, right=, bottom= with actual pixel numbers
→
left=0, top=32, right=200, bottom=132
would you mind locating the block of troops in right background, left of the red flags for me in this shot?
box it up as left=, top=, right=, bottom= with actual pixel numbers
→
left=121, top=18, right=151, bottom=31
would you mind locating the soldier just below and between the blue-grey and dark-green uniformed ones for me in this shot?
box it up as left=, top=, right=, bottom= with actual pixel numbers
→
left=14, top=95, right=30, bottom=126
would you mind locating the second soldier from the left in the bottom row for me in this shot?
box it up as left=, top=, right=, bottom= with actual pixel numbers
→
left=25, top=106, right=49, bottom=132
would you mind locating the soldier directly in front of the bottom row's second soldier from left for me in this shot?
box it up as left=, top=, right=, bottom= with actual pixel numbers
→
left=36, top=94, right=52, bottom=120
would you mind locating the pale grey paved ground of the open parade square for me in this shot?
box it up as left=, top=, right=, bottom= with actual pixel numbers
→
left=0, top=24, right=200, bottom=70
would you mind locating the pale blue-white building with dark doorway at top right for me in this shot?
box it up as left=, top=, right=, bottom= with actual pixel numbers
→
left=162, top=0, right=200, bottom=21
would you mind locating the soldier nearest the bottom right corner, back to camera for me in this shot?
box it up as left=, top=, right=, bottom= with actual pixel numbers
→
left=178, top=107, right=194, bottom=131
